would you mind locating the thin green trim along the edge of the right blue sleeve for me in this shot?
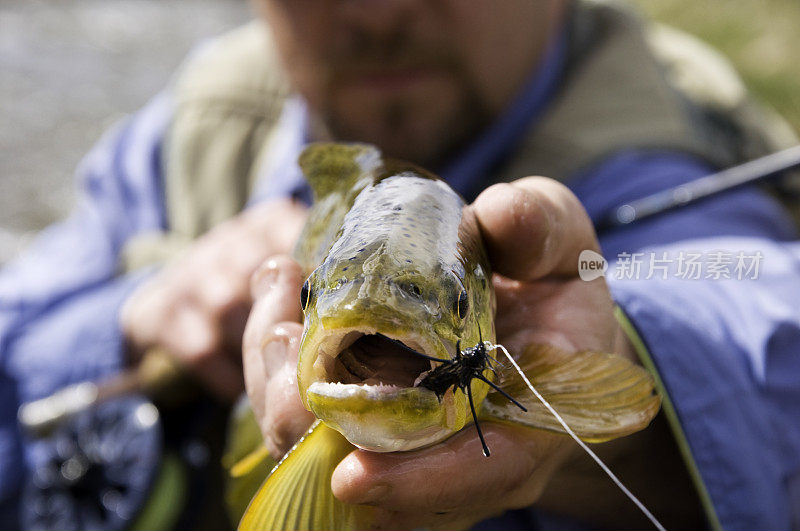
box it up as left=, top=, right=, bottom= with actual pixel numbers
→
left=614, top=306, right=722, bottom=530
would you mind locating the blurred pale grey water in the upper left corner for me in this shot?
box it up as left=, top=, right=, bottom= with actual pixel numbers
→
left=0, top=0, right=249, bottom=264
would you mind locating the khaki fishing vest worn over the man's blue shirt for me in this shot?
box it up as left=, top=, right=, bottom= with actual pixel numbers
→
left=122, top=1, right=796, bottom=270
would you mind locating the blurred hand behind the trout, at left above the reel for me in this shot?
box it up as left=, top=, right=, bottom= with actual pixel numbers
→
left=120, top=200, right=306, bottom=400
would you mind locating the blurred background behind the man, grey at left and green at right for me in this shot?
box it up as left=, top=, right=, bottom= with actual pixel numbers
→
left=0, top=0, right=800, bottom=264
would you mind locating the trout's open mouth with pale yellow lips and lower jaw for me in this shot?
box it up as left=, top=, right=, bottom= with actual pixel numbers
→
left=298, top=327, right=458, bottom=452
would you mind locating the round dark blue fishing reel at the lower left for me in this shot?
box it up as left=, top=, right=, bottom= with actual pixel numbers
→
left=21, top=397, right=166, bottom=530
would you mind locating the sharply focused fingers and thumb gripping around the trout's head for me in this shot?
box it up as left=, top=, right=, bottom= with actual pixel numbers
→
left=244, top=178, right=624, bottom=528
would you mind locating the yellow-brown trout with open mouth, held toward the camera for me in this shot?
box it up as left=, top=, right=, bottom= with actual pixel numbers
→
left=237, top=144, right=660, bottom=529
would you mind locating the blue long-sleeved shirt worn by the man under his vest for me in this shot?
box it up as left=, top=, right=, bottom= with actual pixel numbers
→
left=0, top=30, right=800, bottom=529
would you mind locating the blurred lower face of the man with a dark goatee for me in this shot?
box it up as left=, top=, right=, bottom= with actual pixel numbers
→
left=256, top=0, right=563, bottom=166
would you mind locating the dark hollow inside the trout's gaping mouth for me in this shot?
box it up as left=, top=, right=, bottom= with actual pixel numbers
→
left=318, top=331, right=440, bottom=388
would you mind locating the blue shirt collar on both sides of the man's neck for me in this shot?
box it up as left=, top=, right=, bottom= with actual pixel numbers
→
left=250, top=26, right=567, bottom=203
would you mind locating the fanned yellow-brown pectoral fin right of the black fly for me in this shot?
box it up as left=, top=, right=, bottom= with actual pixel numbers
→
left=483, top=345, right=661, bottom=442
